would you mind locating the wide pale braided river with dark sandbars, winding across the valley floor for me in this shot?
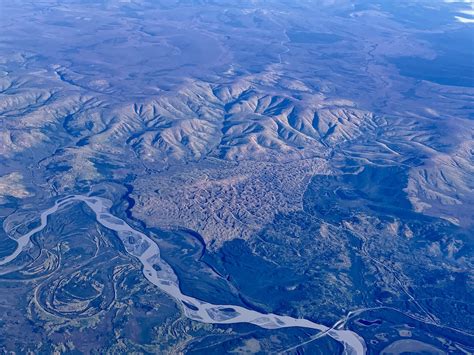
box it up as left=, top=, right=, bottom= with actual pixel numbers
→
left=0, top=195, right=366, bottom=354
